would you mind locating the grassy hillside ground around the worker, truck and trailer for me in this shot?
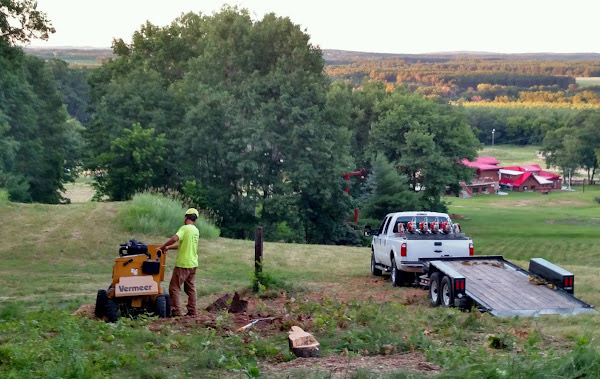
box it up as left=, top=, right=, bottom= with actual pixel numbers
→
left=0, top=187, right=600, bottom=378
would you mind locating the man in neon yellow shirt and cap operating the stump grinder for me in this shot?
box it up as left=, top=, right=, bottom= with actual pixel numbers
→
left=160, top=208, right=200, bottom=317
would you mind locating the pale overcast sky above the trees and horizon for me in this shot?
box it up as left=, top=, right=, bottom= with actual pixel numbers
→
left=27, top=0, right=600, bottom=53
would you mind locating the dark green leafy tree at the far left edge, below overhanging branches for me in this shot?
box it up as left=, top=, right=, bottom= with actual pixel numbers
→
left=0, top=42, right=79, bottom=203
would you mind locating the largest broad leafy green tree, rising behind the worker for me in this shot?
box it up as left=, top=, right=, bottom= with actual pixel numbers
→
left=88, top=8, right=351, bottom=243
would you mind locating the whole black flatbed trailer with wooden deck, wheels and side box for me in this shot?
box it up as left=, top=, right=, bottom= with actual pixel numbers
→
left=420, top=255, right=596, bottom=317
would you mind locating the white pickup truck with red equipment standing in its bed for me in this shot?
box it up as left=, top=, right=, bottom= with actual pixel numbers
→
left=367, top=212, right=474, bottom=286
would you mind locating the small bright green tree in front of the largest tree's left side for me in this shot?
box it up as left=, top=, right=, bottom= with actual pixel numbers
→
left=96, top=123, right=167, bottom=200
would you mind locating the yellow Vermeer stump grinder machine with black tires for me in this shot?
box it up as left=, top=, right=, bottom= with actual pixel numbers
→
left=94, top=239, right=171, bottom=322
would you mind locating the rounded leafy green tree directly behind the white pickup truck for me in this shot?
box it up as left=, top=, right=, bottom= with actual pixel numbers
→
left=370, top=90, right=480, bottom=210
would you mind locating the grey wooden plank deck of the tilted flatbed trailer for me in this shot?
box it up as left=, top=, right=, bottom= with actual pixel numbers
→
left=429, top=256, right=596, bottom=317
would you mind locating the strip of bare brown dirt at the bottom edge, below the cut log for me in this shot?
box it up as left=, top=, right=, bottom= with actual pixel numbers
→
left=262, top=352, right=440, bottom=378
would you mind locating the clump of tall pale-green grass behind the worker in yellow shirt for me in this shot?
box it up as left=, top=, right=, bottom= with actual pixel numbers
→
left=117, top=193, right=220, bottom=238
